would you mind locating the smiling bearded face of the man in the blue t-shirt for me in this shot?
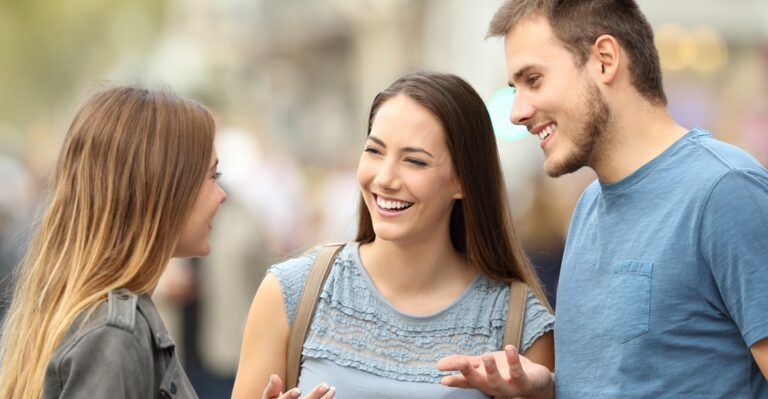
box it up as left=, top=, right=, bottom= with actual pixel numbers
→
left=505, top=16, right=610, bottom=177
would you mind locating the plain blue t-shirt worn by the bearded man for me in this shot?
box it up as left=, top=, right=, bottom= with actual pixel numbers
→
left=555, top=129, right=768, bottom=399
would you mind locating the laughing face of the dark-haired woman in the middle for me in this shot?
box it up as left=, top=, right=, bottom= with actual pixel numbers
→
left=357, top=94, right=462, bottom=242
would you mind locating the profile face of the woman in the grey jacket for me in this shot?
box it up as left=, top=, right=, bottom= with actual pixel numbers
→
left=173, top=149, right=227, bottom=258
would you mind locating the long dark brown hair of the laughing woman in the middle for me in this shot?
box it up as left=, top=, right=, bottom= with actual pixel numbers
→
left=356, top=72, right=548, bottom=306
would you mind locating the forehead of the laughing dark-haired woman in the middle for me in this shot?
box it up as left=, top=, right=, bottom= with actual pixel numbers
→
left=371, top=93, right=445, bottom=144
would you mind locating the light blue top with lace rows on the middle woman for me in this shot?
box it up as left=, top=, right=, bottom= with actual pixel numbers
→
left=269, top=243, right=554, bottom=399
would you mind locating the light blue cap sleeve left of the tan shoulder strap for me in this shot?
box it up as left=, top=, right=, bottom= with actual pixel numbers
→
left=267, top=248, right=319, bottom=325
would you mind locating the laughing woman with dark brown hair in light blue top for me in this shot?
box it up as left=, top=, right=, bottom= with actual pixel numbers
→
left=233, top=73, right=554, bottom=399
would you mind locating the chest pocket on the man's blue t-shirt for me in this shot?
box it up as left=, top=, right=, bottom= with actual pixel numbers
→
left=608, top=260, right=653, bottom=343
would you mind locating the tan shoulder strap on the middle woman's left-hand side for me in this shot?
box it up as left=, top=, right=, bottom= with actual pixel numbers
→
left=283, top=244, right=344, bottom=391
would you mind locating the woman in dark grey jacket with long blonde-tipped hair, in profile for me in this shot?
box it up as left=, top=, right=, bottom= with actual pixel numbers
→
left=0, top=87, right=226, bottom=399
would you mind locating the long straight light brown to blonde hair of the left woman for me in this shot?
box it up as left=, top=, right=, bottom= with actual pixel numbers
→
left=0, top=87, right=215, bottom=399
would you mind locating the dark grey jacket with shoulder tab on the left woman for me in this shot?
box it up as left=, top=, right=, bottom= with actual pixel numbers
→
left=43, top=289, right=197, bottom=399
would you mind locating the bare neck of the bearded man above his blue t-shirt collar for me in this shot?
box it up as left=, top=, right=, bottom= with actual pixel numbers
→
left=591, top=99, right=688, bottom=183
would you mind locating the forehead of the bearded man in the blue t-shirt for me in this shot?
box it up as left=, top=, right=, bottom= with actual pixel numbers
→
left=504, top=15, right=575, bottom=80
